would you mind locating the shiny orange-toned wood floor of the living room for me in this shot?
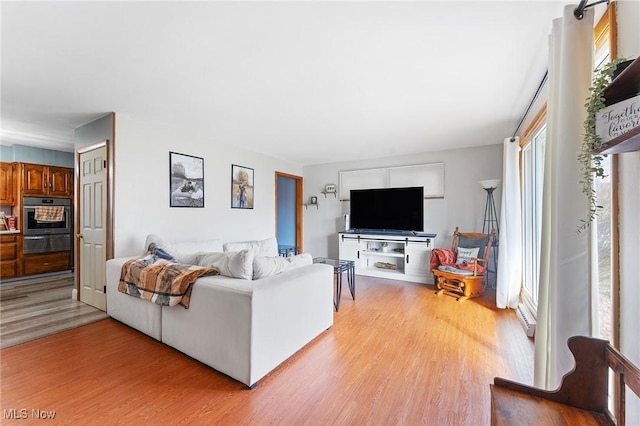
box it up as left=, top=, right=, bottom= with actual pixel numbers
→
left=0, top=277, right=533, bottom=425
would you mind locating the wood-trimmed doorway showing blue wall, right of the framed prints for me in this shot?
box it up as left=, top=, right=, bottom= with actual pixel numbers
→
left=276, top=172, right=303, bottom=252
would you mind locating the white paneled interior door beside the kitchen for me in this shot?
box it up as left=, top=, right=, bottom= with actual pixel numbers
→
left=77, top=145, right=107, bottom=311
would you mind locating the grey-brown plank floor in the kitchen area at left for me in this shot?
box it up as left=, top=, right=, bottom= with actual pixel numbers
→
left=0, top=272, right=107, bottom=348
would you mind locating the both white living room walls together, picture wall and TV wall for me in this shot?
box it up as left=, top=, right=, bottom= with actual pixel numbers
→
left=114, top=109, right=502, bottom=257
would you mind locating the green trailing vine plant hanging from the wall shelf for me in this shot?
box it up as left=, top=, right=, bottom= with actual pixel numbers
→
left=578, top=58, right=627, bottom=233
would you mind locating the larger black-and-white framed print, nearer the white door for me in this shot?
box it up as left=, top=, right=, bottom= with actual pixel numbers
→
left=169, top=152, right=204, bottom=207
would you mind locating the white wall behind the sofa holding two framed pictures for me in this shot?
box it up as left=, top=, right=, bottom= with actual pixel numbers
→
left=114, top=114, right=302, bottom=257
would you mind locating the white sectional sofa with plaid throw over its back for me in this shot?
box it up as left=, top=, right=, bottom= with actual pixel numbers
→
left=107, top=236, right=333, bottom=387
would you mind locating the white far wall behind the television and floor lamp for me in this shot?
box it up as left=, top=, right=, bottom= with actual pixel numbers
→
left=303, top=144, right=502, bottom=258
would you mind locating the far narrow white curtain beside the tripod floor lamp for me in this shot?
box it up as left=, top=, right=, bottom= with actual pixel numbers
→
left=496, top=138, right=522, bottom=309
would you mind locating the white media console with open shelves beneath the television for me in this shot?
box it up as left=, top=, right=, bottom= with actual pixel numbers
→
left=338, top=231, right=436, bottom=284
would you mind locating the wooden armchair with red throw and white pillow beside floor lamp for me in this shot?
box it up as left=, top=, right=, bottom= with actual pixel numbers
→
left=431, top=227, right=493, bottom=302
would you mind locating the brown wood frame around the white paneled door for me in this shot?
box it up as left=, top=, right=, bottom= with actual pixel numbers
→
left=73, top=139, right=114, bottom=301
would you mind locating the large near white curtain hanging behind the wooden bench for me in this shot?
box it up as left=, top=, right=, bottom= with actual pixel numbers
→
left=534, top=5, right=593, bottom=390
